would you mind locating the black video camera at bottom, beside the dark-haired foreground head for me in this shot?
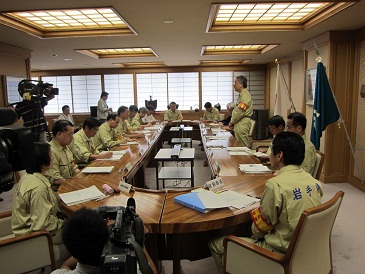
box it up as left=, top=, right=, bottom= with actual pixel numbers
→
left=95, top=198, right=152, bottom=274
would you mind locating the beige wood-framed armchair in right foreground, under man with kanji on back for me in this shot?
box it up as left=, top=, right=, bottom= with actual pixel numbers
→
left=224, top=191, right=344, bottom=274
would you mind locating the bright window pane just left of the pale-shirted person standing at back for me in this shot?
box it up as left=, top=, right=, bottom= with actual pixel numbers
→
left=69, top=75, right=102, bottom=112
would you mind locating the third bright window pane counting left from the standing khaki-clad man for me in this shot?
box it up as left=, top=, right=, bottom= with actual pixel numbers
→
left=137, top=73, right=168, bottom=111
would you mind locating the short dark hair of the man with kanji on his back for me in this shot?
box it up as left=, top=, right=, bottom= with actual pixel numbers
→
left=271, top=131, right=305, bottom=166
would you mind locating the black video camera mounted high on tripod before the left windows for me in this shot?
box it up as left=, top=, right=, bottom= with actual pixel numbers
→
left=18, top=79, right=59, bottom=102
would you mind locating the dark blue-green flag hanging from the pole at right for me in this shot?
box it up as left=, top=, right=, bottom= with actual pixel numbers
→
left=311, top=62, right=340, bottom=149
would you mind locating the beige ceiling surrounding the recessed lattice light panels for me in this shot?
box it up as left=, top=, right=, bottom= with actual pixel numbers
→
left=0, top=0, right=365, bottom=70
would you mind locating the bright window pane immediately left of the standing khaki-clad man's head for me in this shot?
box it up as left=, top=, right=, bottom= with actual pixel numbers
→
left=202, top=71, right=234, bottom=109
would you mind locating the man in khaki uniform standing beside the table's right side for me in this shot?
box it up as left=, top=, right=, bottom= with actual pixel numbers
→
left=228, top=76, right=253, bottom=147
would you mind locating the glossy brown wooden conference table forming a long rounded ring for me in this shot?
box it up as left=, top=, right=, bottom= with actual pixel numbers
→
left=59, top=122, right=272, bottom=273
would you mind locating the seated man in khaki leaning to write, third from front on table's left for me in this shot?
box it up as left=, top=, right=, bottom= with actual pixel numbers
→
left=70, top=117, right=113, bottom=165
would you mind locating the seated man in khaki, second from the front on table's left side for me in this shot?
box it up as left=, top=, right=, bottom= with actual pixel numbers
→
left=46, top=120, right=80, bottom=190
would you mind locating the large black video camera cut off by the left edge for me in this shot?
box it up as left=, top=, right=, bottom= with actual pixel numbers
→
left=0, top=108, right=34, bottom=196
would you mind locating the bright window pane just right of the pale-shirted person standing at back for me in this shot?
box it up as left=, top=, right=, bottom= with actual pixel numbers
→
left=104, top=74, right=134, bottom=112
